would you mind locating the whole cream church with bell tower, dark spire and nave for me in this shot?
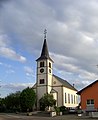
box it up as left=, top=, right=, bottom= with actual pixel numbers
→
left=33, top=32, right=78, bottom=109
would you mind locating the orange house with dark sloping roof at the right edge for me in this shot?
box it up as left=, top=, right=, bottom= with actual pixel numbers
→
left=77, top=80, right=98, bottom=111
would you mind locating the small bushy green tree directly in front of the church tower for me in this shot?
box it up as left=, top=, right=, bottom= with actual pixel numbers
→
left=39, top=94, right=56, bottom=110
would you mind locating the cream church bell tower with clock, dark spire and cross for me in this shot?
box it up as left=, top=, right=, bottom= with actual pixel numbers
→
left=36, top=29, right=53, bottom=108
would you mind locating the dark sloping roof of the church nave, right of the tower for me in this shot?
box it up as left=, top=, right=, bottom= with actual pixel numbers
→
left=53, top=75, right=77, bottom=91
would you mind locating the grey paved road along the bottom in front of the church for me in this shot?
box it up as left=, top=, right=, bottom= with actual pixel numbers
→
left=0, top=114, right=98, bottom=120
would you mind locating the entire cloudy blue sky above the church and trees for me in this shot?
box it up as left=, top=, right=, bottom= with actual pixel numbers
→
left=0, top=0, right=98, bottom=97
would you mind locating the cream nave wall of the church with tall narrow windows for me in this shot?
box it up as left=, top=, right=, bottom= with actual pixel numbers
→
left=53, top=77, right=78, bottom=107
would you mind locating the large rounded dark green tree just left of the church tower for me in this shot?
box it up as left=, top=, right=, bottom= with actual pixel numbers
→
left=20, top=87, right=36, bottom=112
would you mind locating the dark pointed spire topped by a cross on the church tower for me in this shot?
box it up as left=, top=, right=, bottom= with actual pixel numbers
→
left=36, top=29, right=53, bottom=62
